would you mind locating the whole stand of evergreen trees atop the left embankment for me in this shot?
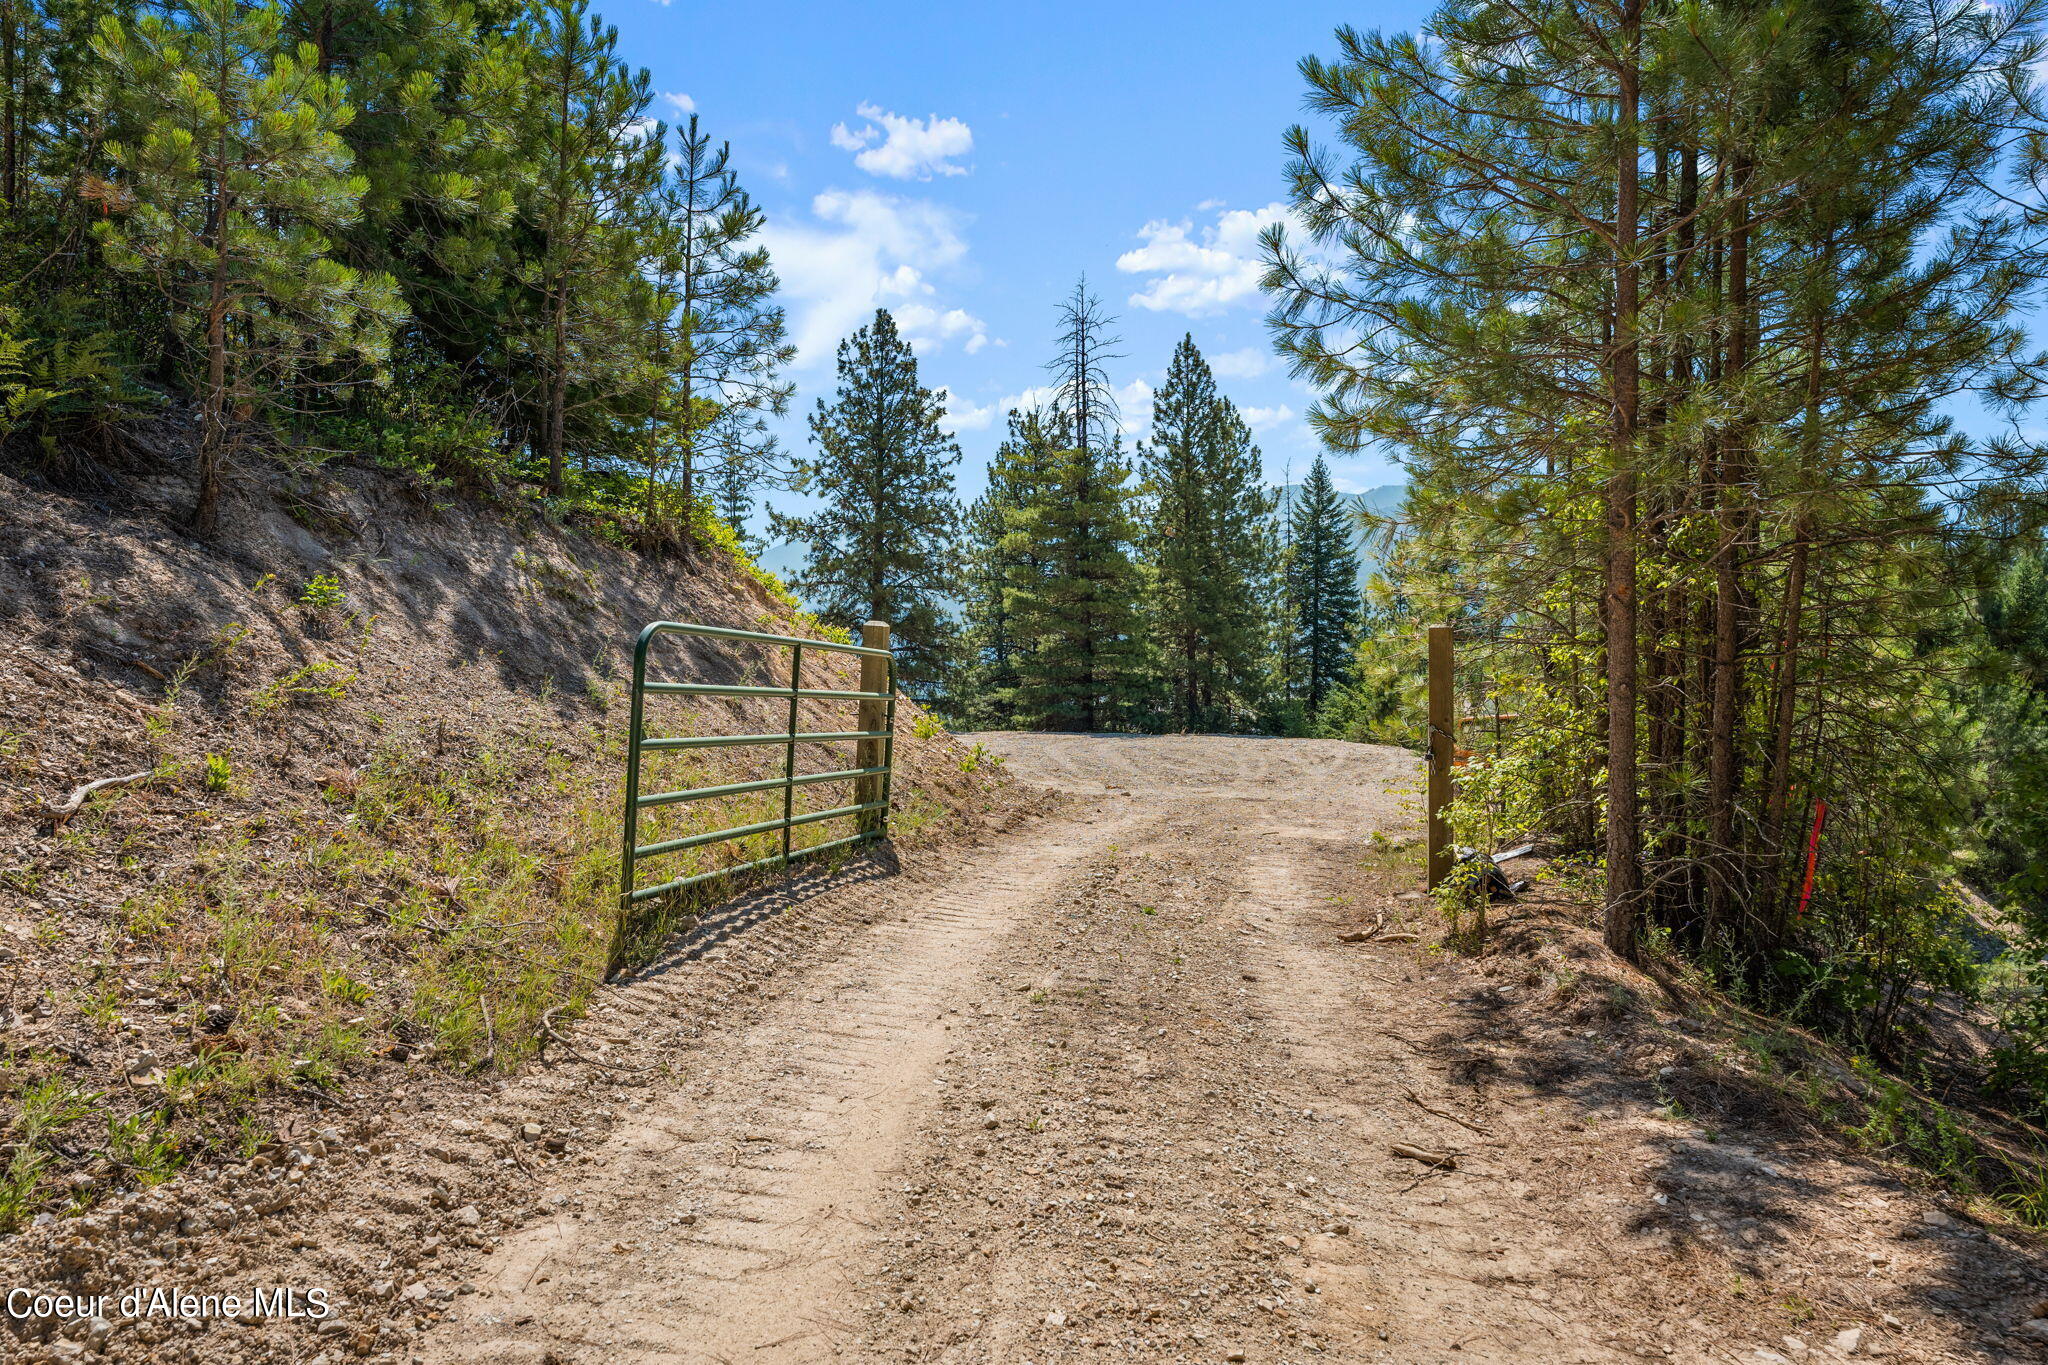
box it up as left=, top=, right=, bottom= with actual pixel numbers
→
left=0, top=0, right=788, bottom=560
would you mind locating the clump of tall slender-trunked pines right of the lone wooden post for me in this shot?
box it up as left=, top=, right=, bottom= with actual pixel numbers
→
left=1268, top=0, right=2044, bottom=965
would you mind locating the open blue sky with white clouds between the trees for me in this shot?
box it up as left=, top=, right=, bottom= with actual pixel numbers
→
left=602, top=0, right=1425, bottom=532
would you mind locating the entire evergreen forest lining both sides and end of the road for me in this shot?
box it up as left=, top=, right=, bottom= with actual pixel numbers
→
left=12, top=0, right=2048, bottom=1137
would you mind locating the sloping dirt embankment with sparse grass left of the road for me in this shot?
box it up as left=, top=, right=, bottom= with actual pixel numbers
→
left=0, top=467, right=1014, bottom=1359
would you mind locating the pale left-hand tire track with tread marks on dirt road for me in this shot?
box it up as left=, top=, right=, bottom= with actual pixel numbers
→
left=430, top=819, right=1122, bottom=1365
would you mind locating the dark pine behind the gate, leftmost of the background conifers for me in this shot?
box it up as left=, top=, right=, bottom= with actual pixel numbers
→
left=774, top=309, right=961, bottom=698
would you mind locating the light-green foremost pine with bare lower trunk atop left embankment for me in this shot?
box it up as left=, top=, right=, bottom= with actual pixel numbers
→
left=96, top=0, right=399, bottom=532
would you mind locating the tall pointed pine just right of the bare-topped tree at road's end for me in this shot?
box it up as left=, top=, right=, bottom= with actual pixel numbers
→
left=1141, top=336, right=1276, bottom=731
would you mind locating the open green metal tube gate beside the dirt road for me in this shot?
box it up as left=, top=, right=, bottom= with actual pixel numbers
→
left=618, top=620, right=895, bottom=911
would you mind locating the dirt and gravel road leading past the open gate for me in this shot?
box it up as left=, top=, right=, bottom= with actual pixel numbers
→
left=420, top=735, right=2023, bottom=1365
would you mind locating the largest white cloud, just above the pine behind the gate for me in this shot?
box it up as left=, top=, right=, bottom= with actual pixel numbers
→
left=762, top=190, right=989, bottom=370
